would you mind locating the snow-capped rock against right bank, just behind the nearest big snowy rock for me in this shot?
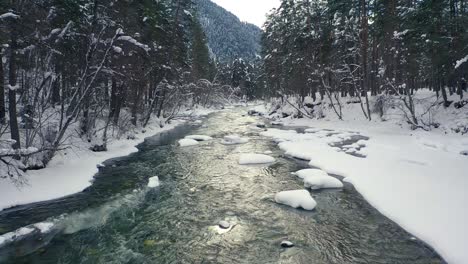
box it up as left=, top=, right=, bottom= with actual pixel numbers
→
left=293, top=169, right=343, bottom=190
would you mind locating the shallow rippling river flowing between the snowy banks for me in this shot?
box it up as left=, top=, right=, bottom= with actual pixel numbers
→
left=0, top=108, right=443, bottom=264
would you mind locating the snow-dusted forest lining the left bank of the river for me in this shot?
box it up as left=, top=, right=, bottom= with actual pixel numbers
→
left=0, top=0, right=238, bottom=177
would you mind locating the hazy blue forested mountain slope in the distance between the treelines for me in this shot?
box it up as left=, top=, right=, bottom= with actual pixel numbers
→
left=194, top=0, right=262, bottom=62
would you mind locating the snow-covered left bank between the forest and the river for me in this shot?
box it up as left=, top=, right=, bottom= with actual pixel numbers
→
left=0, top=120, right=181, bottom=210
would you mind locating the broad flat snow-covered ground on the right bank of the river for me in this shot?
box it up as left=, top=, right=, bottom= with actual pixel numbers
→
left=255, top=97, right=468, bottom=263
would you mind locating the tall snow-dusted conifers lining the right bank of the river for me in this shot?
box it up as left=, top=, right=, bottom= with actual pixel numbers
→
left=262, top=0, right=468, bottom=126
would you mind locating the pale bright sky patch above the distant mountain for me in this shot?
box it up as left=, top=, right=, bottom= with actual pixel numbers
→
left=212, top=0, right=280, bottom=27
